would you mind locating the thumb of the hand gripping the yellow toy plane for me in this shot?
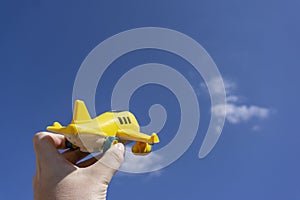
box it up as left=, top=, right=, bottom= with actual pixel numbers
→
left=91, top=143, right=125, bottom=183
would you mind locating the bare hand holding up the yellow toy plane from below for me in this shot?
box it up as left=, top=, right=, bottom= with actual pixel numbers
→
left=32, top=132, right=125, bottom=200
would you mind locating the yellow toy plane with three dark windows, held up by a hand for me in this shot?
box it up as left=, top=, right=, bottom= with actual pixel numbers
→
left=47, top=100, right=159, bottom=154
